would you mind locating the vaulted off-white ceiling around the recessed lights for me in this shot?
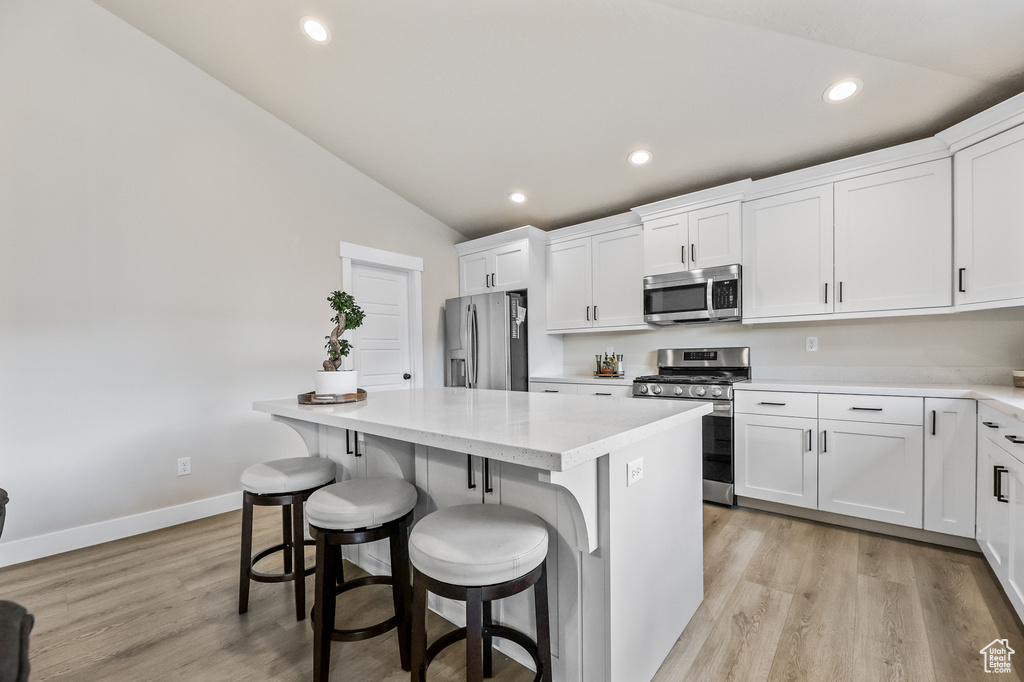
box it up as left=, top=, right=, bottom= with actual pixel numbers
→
left=94, top=0, right=1024, bottom=237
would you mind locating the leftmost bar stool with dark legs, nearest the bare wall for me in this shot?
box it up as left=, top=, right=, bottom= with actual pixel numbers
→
left=239, top=457, right=337, bottom=621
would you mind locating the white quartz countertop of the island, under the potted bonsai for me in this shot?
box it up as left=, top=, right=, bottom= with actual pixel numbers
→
left=253, top=388, right=712, bottom=471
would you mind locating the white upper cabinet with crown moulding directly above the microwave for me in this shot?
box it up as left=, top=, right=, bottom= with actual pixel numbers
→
left=633, top=180, right=751, bottom=275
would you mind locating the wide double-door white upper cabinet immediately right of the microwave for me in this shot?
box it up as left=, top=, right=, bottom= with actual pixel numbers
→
left=742, top=139, right=952, bottom=323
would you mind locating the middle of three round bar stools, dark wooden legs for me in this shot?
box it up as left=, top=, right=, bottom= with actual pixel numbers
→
left=306, top=478, right=417, bottom=682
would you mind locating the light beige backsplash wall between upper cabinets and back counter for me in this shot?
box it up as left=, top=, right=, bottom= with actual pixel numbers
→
left=564, top=308, right=1024, bottom=385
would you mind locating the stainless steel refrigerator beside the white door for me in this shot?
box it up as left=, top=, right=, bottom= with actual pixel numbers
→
left=444, top=292, right=529, bottom=391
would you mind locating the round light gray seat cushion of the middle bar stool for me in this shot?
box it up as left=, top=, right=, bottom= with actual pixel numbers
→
left=306, top=478, right=417, bottom=530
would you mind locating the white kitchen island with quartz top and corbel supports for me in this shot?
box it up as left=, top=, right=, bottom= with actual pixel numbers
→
left=253, top=388, right=711, bottom=682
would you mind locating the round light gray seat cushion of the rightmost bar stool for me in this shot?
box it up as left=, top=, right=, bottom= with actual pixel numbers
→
left=409, top=505, right=548, bottom=586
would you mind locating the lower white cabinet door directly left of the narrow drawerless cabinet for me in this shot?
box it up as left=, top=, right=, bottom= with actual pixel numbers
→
left=818, top=420, right=924, bottom=528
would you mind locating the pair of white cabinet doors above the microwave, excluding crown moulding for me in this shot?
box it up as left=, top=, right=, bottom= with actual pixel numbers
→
left=643, top=201, right=743, bottom=275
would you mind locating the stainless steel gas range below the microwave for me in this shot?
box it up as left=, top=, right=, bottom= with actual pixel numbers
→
left=633, top=348, right=751, bottom=505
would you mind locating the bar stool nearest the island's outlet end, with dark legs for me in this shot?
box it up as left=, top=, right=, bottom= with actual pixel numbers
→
left=409, top=504, right=551, bottom=682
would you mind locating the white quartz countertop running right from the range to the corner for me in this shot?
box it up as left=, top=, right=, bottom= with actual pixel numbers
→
left=733, top=379, right=1024, bottom=420
